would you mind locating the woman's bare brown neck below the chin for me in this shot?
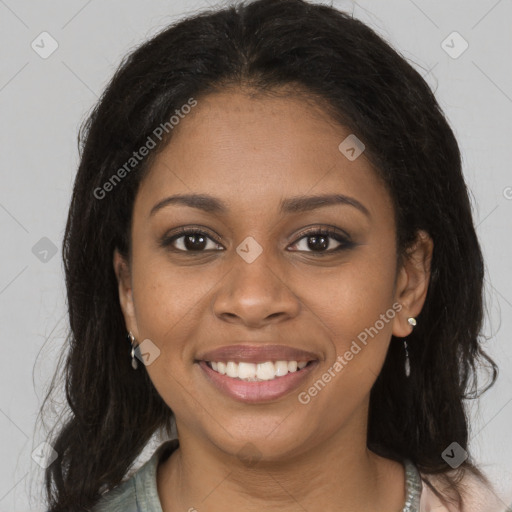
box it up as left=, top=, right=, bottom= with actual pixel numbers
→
left=157, top=422, right=405, bottom=512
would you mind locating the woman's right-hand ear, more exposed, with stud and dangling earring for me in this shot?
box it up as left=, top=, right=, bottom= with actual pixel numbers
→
left=393, top=230, right=434, bottom=338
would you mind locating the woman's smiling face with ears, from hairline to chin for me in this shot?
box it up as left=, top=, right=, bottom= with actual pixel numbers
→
left=114, top=90, right=432, bottom=460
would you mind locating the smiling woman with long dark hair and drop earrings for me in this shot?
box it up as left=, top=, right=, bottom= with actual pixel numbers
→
left=42, top=0, right=506, bottom=512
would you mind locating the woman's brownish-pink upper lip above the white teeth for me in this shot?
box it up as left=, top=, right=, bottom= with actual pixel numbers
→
left=197, top=345, right=318, bottom=363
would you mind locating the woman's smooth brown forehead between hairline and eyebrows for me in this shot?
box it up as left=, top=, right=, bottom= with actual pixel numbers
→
left=133, top=90, right=389, bottom=222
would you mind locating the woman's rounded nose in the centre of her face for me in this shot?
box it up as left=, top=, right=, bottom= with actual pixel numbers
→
left=212, top=251, right=301, bottom=328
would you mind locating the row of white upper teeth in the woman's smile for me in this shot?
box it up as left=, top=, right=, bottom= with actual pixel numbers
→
left=205, top=361, right=308, bottom=381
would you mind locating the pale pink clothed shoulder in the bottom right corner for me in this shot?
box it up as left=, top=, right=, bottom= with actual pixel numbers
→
left=420, top=471, right=512, bottom=512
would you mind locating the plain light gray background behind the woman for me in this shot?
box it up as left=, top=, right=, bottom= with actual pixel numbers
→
left=0, top=0, right=512, bottom=512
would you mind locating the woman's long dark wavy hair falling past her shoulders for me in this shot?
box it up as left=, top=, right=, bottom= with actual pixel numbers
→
left=41, top=0, right=498, bottom=512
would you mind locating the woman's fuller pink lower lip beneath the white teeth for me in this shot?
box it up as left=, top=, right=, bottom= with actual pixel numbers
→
left=199, top=361, right=318, bottom=403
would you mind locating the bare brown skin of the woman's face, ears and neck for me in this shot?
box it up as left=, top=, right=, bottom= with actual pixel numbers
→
left=113, top=89, right=433, bottom=512
